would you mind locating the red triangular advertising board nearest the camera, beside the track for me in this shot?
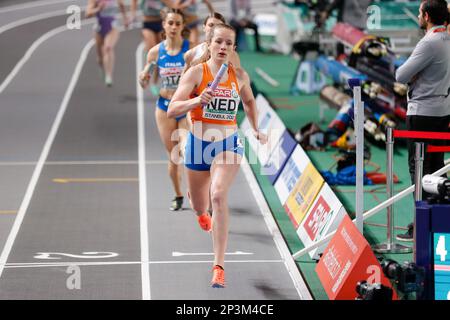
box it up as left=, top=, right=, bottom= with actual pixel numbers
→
left=316, top=215, right=396, bottom=300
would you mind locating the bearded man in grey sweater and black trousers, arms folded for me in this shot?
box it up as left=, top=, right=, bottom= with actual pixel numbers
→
left=396, top=0, right=450, bottom=241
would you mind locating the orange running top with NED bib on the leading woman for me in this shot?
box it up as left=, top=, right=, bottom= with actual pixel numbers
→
left=189, top=62, right=241, bottom=125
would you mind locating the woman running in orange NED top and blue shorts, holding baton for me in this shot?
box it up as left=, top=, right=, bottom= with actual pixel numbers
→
left=167, top=24, right=267, bottom=288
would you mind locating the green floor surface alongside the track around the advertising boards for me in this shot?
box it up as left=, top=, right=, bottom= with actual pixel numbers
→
left=239, top=52, right=414, bottom=300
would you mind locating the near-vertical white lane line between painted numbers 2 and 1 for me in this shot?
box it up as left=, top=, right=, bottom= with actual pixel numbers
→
left=136, top=42, right=151, bottom=300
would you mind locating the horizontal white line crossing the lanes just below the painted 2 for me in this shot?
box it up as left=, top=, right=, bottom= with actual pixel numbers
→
left=5, top=260, right=284, bottom=269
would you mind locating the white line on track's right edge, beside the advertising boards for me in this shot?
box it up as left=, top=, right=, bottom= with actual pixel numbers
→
left=241, top=157, right=312, bottom=300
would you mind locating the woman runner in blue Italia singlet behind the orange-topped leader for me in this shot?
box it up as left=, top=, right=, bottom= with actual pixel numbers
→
left=139, top=9, right=190, bottom=210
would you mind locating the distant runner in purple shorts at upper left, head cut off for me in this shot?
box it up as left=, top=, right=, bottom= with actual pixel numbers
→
left=86, top=0, right=128, bottom=87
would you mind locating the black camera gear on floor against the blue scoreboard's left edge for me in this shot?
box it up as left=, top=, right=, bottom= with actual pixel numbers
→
left=381, top=259, right=425, bottom=295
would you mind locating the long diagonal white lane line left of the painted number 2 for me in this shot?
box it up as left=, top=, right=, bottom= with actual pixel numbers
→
left=0, top=40, right=94, bottom=277
